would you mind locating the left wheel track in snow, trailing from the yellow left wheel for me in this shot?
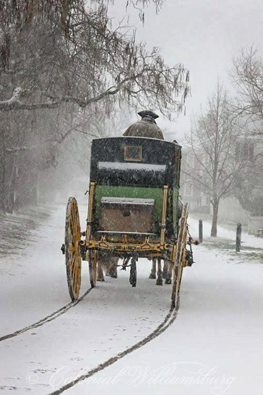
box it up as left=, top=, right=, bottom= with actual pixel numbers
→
left=0, top=288, right=92, bottom=342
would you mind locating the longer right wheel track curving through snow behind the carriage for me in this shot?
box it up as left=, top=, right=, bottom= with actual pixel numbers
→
left=49, top=301, right=179, bottom=395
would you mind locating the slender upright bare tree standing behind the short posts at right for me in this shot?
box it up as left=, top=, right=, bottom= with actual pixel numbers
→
left=184, top=84, right=240, bottom=237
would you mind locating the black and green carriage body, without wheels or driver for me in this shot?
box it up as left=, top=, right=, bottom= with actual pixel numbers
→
left=90, top=137, right=181, bottom=248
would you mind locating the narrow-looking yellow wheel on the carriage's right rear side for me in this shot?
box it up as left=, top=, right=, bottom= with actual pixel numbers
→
left=172, top=204, right=188, bottom=307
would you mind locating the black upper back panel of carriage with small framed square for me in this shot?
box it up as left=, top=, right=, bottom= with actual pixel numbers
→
left=90, top=137, right=181, bottom=186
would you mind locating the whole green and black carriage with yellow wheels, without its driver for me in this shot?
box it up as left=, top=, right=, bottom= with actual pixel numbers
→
left=61, top=116, right=192, bottom=306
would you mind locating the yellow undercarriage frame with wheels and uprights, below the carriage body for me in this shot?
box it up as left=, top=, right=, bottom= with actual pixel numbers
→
left=62, top=189, right=190, bottom=307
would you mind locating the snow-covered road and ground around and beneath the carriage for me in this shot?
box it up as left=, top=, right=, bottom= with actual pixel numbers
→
left=0, top=207, right=263, bottom=395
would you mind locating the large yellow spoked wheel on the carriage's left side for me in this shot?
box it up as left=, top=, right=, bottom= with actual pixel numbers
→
left=65, top=197, right=81, bottom=301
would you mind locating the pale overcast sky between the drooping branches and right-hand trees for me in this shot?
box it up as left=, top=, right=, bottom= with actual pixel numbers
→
left=111, top=0, right=263, bottom=140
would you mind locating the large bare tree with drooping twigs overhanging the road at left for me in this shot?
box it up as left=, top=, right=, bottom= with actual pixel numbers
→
left=0, top=0, right=189, bottom=210
